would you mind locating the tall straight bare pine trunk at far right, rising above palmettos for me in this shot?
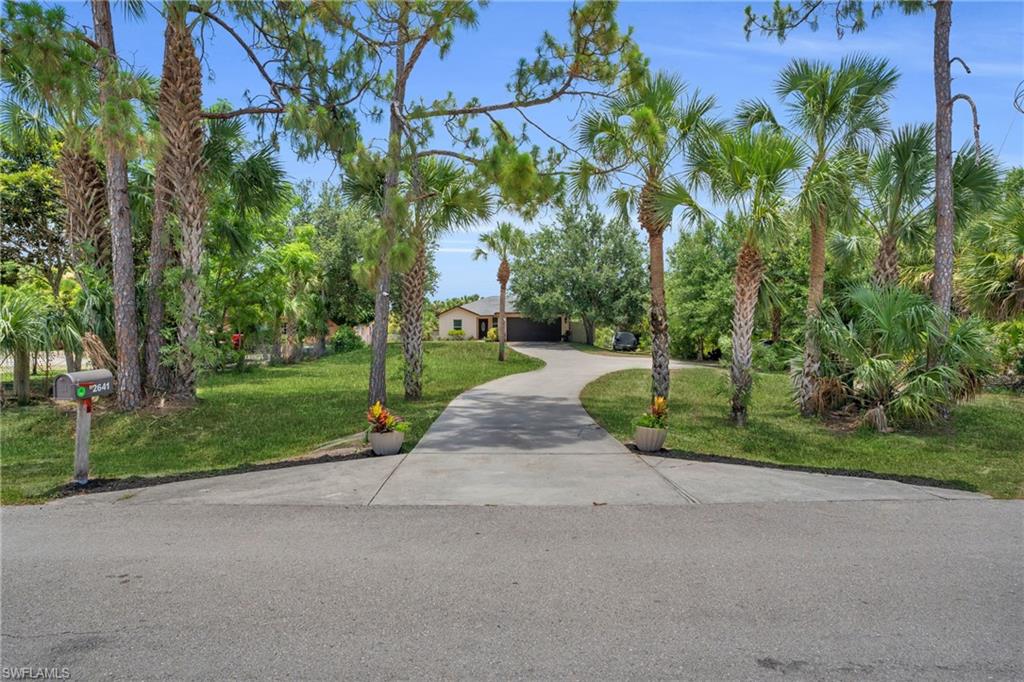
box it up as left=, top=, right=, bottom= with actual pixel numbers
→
left=932, top=0, right=954, bottom=331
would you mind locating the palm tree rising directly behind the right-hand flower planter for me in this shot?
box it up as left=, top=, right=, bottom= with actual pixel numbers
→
left=573, top=73, right=715, bottom=397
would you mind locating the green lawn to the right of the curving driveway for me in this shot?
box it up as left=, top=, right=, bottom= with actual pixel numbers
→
left=582, top=369, right=1024, bottom=498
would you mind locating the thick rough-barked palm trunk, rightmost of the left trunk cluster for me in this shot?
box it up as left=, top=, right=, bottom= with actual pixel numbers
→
left=164, top=5, right=206, bottom=401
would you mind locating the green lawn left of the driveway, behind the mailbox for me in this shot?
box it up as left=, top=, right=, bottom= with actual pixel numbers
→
left=0, top=342, right=543, bottom=504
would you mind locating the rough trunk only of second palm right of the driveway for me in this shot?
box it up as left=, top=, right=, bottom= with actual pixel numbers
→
left=729, top=243, right=764, bottom=426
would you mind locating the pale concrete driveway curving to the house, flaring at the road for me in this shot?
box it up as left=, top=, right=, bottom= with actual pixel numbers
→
left=55, top=344, right=985, bottom=506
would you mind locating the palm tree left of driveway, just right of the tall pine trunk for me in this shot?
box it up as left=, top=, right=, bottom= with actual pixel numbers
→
left=400, top=158, right=492, bottom=400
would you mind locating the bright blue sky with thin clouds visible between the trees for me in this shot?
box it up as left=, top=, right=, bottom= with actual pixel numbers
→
left=59, top=0, right=1024, bottom=298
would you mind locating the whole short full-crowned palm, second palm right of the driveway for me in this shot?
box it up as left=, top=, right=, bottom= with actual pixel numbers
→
left=691, top=128, right=805, bottom=426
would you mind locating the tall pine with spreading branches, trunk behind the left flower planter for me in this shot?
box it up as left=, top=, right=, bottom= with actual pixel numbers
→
left=296, top=0, right=639, bottom=402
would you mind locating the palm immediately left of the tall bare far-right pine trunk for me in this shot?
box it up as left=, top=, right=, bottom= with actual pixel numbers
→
left=864, top=125, right=935, bottom=287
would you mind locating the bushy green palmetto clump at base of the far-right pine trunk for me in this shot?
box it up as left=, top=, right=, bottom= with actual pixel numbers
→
left=814, top=286, right=991, bottom=431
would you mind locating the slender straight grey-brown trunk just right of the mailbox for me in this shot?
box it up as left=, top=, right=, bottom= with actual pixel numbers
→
left=92, top=0, right=142, bottom=411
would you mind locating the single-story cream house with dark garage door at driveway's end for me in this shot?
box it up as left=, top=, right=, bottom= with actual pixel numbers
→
left=437, top=295, right=569, bottom=341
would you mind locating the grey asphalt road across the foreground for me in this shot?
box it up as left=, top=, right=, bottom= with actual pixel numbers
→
left=0, top=500, right=1024, bottom=680
